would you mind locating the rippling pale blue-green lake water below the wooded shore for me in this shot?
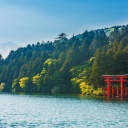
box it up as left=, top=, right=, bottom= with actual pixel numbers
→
left=0, top=93, right=128, bottom=128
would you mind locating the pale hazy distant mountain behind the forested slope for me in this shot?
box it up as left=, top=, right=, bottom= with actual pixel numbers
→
left=0, top=42, right=19, bottom=58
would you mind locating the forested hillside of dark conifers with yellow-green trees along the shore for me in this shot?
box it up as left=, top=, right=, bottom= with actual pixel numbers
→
left=0, top=25, right=128, bottom=95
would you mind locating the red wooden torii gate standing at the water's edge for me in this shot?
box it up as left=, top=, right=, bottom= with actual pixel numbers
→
left=102, top=74, right=128, bottom=97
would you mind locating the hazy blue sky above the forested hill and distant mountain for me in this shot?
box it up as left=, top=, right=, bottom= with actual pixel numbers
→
left=0, top=0, right=128, bottom=46
